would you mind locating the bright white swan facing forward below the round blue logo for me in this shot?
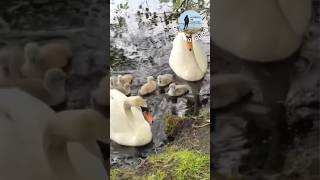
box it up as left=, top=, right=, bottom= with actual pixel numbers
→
left=169, top=33, right=208, bottom=81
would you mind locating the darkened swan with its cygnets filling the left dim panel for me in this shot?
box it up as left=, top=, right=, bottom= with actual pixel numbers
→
left=0, top=42, right=109, bottom=180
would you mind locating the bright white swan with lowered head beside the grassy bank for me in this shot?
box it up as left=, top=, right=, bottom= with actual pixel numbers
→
left=110, top=89, right=152, bottom=146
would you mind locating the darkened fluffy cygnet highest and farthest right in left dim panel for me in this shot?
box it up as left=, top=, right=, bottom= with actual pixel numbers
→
left=21, top=42, right=72, bottom=79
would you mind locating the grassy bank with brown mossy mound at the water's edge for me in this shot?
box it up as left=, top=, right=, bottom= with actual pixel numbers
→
left=111, top=109, right=211, bottom=180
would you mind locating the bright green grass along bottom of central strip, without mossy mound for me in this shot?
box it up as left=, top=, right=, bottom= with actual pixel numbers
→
left=111, top=146, right=210, bottom=180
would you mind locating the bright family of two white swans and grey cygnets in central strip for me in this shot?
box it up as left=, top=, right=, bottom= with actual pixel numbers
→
left=110, top=28, right=208, bottom=146
